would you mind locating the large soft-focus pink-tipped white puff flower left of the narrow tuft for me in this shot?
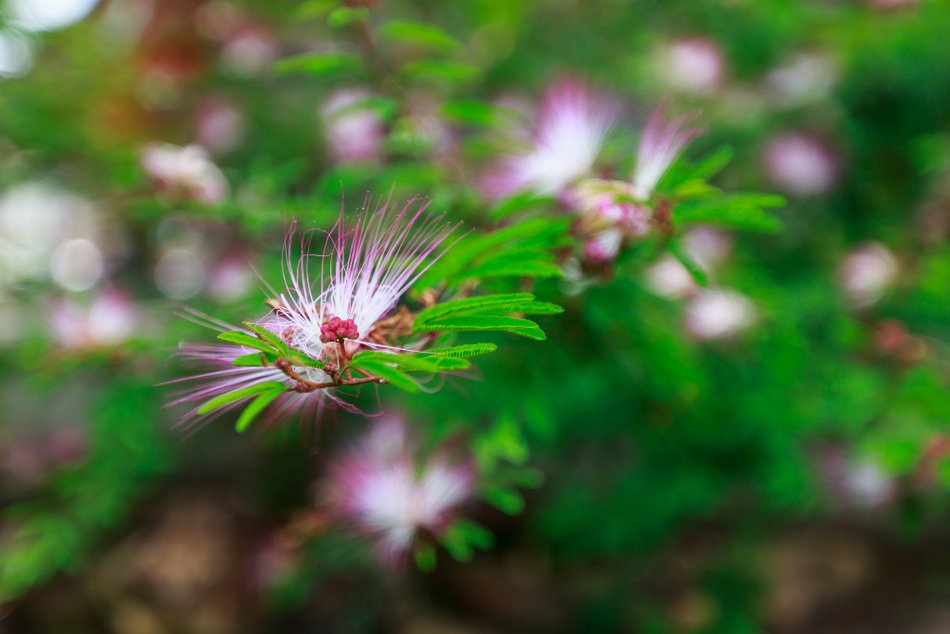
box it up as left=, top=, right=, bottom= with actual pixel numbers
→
left=483, top=78, right=618, bottom=198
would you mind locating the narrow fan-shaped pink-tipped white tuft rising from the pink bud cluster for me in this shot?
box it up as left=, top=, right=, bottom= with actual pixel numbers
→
left=632, top=106, right=704, bottom=200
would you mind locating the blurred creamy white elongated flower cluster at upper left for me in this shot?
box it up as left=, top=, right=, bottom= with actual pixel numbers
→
left=141, top=143, right=229, bottom=205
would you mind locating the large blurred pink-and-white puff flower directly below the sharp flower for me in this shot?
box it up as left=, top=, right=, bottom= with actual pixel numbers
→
left=326, top=418, right=475, bottom=563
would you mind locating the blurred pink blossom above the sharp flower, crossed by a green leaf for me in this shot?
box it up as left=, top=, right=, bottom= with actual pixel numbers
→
left=320, top=88, right=384, bottom=163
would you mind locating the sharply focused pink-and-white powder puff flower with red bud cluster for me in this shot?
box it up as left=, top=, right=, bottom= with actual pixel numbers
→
left=169, top=200, right=455, bottom=425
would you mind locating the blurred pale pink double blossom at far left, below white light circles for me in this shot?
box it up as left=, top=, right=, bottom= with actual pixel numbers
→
left=49, top=289, right=138, bottom=350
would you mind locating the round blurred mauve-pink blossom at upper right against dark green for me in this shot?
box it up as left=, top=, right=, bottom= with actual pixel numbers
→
left=763, top=132, right=839, bottom=196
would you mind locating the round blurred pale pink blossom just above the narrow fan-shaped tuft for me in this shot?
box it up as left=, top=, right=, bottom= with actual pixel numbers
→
left=656, top=37, right=725, bottom=93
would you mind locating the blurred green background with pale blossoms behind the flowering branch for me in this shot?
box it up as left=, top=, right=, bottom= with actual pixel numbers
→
left=0, top=0, right=950, bottom=634
